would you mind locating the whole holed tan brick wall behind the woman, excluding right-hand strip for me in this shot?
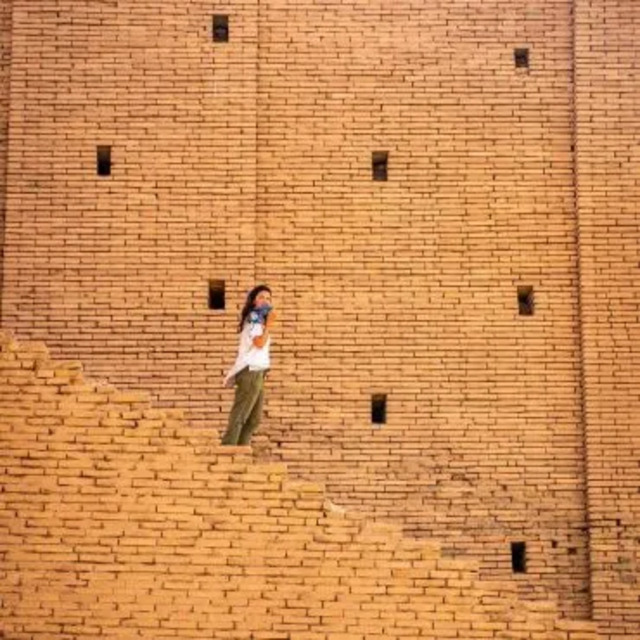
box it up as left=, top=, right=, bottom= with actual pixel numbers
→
left=3, top=0, right=589, bottom=616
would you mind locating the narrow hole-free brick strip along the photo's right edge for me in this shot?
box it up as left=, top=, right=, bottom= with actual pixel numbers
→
left=576, top=0, right=640, bottom=638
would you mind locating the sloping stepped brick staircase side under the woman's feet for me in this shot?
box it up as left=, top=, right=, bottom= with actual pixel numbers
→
left=0, top=334, right=599, bottom=640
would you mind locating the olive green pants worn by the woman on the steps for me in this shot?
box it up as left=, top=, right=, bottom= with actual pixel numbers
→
left=222, top=367, right=265, bottom=445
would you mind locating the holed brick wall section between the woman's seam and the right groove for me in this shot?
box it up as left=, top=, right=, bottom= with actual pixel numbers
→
left=256, top=0, right=589, bottom=615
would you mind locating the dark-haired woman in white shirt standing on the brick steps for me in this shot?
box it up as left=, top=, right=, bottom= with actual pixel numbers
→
left=222, top=284, right=275, bottom=445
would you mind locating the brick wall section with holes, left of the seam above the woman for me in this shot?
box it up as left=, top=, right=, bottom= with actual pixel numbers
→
left=3, top=0, right=257, bottom=423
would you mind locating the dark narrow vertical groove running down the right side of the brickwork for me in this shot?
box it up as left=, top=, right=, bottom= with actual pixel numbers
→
left=571, top=0, right=593, bottom=619
